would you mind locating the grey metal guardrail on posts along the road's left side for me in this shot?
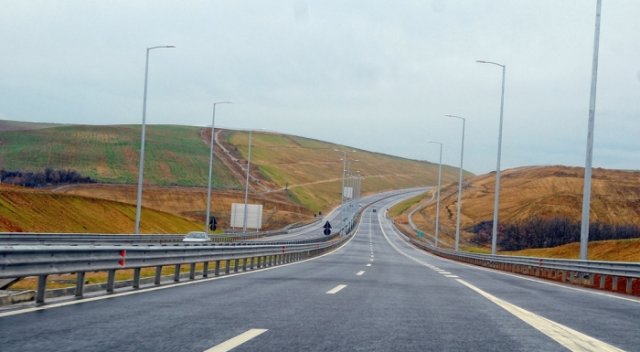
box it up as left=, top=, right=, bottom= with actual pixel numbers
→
left=0, top=234, right=348, bottom=304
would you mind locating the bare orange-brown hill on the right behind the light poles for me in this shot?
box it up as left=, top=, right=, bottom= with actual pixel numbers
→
left=398, top=166, right=640, bottom=255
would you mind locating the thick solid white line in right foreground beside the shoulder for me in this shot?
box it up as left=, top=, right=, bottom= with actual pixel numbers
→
left=456, top=279, right=623, bottom=352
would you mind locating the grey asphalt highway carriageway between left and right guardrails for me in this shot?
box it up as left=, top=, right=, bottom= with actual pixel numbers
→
left=0, top=197, right=640, bottom=351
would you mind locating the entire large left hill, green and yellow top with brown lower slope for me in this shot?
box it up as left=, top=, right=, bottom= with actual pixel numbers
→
left=0, top=121, right=464, bottom=233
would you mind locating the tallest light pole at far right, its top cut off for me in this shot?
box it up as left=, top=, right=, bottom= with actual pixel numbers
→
left=580, top=0, right=602, bottom=260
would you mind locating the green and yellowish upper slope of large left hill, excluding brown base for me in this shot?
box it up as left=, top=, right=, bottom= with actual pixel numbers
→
left=0, top=121, right=468, bottom=212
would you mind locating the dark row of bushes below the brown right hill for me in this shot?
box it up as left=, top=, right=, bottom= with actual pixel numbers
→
left=468, top=217, right=640, bottom=251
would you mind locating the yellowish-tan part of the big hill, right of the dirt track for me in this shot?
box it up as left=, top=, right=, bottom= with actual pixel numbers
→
left=226, top=132, right=464, bottom=211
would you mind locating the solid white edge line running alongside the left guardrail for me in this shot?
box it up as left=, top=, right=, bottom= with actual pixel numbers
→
left=0, top=214, right=364, bottom=318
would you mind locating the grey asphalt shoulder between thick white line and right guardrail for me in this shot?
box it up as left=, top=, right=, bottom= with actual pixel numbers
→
left=383, top=209, right=640, bottom=351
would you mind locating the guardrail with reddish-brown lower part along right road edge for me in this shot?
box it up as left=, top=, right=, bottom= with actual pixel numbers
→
left=394, top=225, right=640, bottom=296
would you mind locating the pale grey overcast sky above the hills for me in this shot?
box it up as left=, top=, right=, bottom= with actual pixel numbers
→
left=0, top=0, right=640, bottom=173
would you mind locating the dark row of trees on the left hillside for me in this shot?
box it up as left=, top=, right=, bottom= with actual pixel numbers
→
left=0, top=168, right=96, bottom=188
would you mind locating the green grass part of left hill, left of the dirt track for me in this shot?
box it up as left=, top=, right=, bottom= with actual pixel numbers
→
left=0, top=125, right=240, bottom=189
